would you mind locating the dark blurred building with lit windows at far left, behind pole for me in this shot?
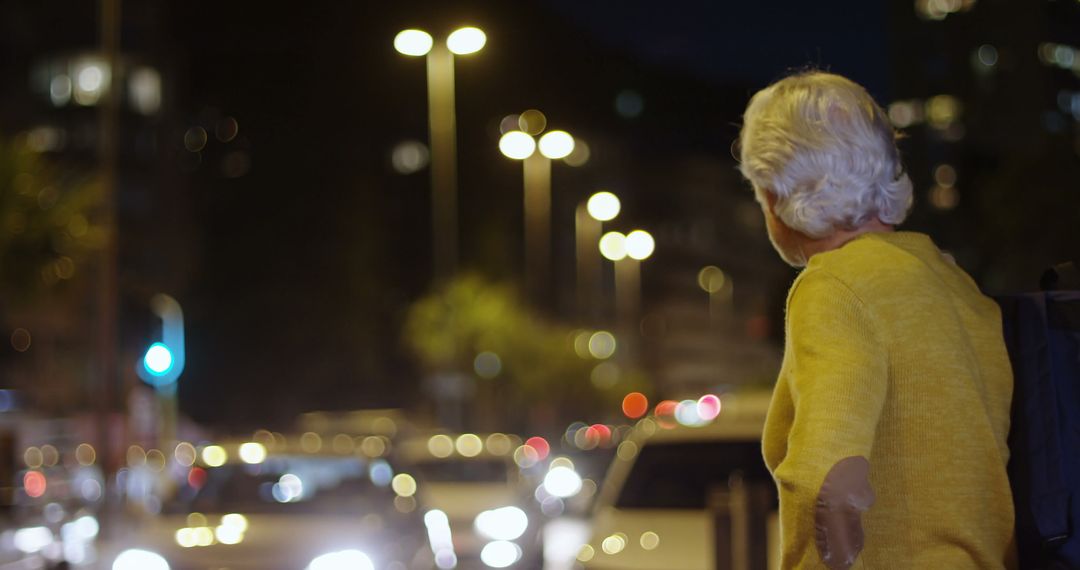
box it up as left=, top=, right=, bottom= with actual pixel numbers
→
left=0, top=1, right=194, bottom=413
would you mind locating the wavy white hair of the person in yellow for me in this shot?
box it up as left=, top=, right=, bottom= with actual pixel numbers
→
left=739, top=71, right=912, bottom=238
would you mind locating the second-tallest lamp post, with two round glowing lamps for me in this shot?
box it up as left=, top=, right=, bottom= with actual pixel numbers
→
left=499, top=125, right=573, bottom=304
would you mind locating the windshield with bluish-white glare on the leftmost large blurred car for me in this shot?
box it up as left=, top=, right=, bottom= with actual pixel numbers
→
left=174, top=458, right=392, bottom=515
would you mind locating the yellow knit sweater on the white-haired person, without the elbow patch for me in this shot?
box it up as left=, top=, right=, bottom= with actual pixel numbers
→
left=762, top=232, right=1016, bottom=570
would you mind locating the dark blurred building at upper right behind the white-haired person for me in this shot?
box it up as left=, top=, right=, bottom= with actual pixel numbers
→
left=882, top=0, right=1080, bottom=291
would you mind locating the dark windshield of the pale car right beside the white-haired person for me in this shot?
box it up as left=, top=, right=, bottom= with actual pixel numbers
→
left=616, top=442, right=769, bottom=510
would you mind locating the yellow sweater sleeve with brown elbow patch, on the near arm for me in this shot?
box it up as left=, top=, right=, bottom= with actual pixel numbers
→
left=773, top=270, right=888, bottom=568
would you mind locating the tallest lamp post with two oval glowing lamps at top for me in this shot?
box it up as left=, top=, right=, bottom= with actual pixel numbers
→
left=394, top=27, right=487, bottom=281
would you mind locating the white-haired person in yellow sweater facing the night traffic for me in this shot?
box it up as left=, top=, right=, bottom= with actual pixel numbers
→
left=740, top=71, right=1015, bottom=569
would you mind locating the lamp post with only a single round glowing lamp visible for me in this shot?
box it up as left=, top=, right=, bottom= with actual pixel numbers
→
left=575, top=191, right=621, bottom=317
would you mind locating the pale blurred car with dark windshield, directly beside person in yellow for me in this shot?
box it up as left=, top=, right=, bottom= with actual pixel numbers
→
left=578, top=393, right=778, bottom=570
